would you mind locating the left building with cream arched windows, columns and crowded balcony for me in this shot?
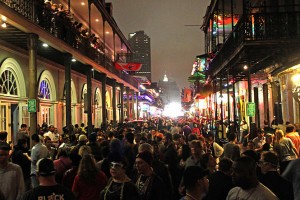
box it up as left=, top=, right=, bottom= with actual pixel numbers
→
left=0, top=0, right=138, bottom=141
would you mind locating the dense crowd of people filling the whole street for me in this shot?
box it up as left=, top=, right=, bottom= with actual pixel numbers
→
left=0, top=118, right=300, bottom=200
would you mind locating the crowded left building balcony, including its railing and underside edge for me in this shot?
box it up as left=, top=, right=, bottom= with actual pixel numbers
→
left=0, top=0, right=138, bottom=88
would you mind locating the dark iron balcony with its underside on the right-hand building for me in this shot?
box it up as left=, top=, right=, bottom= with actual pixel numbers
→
left=209, top=12, right=300, bottom=76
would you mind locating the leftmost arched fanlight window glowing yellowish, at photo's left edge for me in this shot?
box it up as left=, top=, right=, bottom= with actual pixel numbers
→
left=0, top=70, right=18, bottom=96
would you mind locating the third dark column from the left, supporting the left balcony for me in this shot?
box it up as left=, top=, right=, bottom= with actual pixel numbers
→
left=84, top=65, right=94, bottom=135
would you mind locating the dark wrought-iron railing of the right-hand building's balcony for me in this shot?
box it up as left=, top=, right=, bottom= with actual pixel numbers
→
left=209, top=12, right=300, bottom=73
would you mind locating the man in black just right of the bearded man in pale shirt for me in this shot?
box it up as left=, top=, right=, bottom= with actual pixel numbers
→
left=259, top=151, right=294, bottom=200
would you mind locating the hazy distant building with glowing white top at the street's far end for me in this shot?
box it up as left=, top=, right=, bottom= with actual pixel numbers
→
left=158, top=74, right=181, bottom=105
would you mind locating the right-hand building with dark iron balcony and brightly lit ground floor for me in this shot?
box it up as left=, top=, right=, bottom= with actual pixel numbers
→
left=202, top=0, right=300, bottom=128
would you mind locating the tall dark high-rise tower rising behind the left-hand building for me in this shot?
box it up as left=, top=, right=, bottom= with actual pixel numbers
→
left=128, top=31, right=151, bottom=81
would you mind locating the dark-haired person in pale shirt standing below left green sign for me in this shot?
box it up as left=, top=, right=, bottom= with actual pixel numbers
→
left=30, top=134, right=48, bottom=188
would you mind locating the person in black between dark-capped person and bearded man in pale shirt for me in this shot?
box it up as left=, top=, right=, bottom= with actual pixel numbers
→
left=205, top=158, right=234, bottom=200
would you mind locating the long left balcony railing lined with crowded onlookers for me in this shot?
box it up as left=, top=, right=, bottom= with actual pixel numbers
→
left=0, top=0, right=138, bottom=88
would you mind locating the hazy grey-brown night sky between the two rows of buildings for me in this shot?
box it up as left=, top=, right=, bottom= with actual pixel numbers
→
left=106, top=0, right=210, bottom=89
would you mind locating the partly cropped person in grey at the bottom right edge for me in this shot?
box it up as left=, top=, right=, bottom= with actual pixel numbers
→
left=282, top=158, right=300, bottom=200
